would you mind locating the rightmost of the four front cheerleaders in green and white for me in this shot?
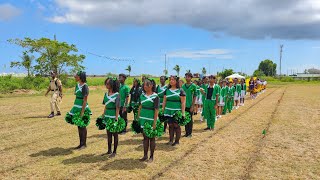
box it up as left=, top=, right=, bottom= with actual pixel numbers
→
left=162, top=76, right=186, bottom=146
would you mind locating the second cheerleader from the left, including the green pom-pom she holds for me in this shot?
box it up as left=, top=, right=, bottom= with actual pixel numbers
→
left=102, top=77, right=125, bottom=158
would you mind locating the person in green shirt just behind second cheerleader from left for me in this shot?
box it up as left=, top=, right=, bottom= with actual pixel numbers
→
left=119, top=74, right=130, bottom=133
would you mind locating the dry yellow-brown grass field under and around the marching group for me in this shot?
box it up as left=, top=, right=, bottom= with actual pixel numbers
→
left=0, top=84, right=320, bottom=179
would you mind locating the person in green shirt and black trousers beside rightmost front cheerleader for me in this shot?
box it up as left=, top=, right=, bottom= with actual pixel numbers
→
left=182, top=73, right=197, bottom=138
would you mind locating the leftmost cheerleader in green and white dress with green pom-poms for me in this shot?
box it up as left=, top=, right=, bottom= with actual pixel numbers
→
left=65, top=71, right=91, bottom=149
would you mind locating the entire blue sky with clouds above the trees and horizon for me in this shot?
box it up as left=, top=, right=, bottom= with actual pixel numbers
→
left=0, top=0, right=320, bottom=75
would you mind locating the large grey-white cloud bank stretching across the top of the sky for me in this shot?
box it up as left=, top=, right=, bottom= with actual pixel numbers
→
left=49, top=0, right=320, bottom=39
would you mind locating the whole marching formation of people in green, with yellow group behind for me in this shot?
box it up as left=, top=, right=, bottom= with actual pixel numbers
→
left=59, top=71, right=267, bottom=162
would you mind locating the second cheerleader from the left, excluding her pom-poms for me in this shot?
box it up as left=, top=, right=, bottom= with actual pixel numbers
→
left=102, top=78, right=120, bottom=158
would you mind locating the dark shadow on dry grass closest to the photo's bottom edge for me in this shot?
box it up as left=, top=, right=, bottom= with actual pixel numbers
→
left=100, top=159, right=147, bottom=171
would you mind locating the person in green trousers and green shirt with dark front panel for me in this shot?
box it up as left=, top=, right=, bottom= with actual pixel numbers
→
left=200, top=75, right=220, bottom=131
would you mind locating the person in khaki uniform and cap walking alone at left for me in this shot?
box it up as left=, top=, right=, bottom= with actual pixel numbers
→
left=45, top=71, right=62, bottom=118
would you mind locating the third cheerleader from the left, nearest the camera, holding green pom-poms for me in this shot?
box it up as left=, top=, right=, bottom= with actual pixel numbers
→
left=138, top=78, right=163, bottom=162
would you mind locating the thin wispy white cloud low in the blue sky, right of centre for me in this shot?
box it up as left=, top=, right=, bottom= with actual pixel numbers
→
left=167, top=49, right=233, bottom=59
